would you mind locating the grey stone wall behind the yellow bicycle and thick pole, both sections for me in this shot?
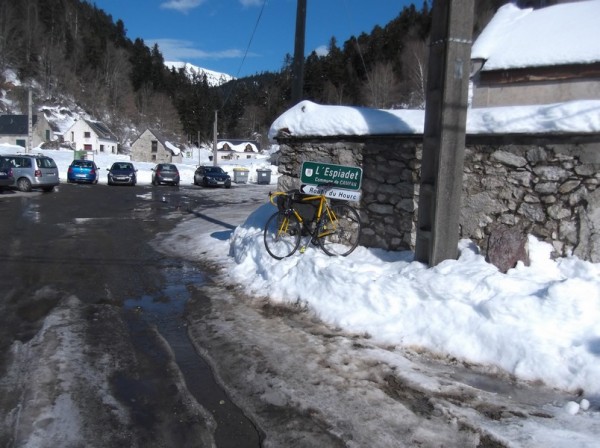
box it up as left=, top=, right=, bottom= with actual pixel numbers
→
left=279, top=137, right=600, bottom=262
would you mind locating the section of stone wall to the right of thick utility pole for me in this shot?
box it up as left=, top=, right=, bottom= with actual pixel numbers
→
left=461, top=143, right=600, bottom=262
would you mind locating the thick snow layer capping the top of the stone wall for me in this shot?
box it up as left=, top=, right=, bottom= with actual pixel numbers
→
left=269, top=100, right=600, bottom=139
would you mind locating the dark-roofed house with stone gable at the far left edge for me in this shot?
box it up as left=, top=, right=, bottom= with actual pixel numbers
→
left=0, top=114, right=54, bottom=148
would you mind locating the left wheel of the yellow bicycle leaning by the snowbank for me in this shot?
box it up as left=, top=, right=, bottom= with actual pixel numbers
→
left=264, top=212, right=302, bottom=260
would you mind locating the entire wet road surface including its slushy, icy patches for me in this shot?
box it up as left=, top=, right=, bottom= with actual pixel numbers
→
left=0, top=185, right=600, bottom=448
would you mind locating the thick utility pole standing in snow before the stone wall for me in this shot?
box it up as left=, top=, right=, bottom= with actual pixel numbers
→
left=415, top=0, right=474, bottom=266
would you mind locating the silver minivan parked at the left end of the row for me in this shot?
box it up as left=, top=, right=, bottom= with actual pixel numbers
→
left=3, top=154, right=60, bottom=191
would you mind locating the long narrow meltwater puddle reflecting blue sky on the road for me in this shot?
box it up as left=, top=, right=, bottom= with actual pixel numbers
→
left=124, top=260, right=260, bottom=448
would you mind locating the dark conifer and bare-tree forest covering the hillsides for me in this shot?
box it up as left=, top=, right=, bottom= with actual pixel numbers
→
left=0, top=0, right=558, bottom=150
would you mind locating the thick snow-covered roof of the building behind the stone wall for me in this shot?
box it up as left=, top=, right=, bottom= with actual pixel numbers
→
left=471, top=0, right=600, bottom=71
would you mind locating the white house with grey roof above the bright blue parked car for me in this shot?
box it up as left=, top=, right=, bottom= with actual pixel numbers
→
left=63, top=119, right=119, bottom=154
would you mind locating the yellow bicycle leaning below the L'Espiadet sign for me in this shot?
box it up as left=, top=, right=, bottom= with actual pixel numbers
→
left=264, top=191, right=361, bottom=260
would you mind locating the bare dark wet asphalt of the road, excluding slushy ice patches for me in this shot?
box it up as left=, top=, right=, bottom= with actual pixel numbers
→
left=0, top=185, right=260, bottom=447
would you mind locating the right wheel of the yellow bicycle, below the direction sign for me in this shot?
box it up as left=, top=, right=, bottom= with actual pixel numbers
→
left=318, top=204, right=361, bottom=257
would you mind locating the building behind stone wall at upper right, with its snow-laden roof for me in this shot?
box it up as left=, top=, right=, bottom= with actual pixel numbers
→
left=471, top=1, right=600, bottom=107
